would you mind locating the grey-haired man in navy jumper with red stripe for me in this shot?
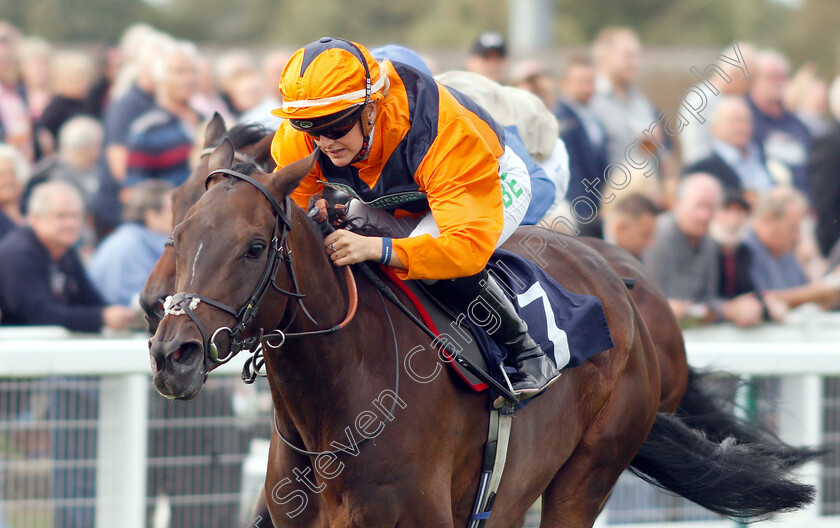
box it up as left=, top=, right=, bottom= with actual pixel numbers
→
left=124, top=42, right=201, bottom=187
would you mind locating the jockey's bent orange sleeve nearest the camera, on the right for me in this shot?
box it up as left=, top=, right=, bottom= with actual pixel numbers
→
left=393, top=116, right=504, bottom=279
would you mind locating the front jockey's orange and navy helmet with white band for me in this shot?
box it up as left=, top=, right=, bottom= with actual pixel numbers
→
left=272, top=37, right=385, bottom=136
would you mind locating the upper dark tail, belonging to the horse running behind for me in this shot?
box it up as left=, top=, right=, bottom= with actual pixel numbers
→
left=676, top=367, right=824, bottom=468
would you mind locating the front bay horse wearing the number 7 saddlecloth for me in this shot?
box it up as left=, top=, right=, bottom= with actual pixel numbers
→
left=150, top=142, right=812, bottom=527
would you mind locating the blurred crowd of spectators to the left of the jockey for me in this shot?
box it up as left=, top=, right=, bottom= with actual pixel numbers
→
left=0, top=21, right=288, bottom=332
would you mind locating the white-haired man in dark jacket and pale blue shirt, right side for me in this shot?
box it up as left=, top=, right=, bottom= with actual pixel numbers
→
left=686, top=96, right=774, bottom=202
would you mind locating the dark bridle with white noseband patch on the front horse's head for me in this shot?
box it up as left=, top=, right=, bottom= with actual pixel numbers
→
left=164, top=165, right=358, bottom=364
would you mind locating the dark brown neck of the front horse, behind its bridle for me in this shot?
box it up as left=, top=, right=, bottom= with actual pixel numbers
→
left=265, top=208, right=376, bottom=449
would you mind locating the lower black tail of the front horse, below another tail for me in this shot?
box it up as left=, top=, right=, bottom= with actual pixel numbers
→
left=630, top=413, right=815, bottom=519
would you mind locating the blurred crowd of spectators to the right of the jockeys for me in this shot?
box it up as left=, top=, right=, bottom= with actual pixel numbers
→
left=467, top=27, right=840, bottom=326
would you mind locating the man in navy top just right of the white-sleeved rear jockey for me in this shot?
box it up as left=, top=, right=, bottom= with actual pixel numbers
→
left=554, top=55, right=607, bottom=207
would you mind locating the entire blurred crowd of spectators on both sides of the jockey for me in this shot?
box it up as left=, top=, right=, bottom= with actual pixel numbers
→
left=0, top=22, right=840, bottom=338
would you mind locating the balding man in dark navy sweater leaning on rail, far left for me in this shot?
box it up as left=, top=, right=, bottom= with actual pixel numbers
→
left=0, top=181, right=134, bottom=332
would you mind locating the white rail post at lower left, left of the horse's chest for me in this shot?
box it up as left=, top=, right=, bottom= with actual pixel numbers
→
left=96, top=374, right=149, bottom=528
